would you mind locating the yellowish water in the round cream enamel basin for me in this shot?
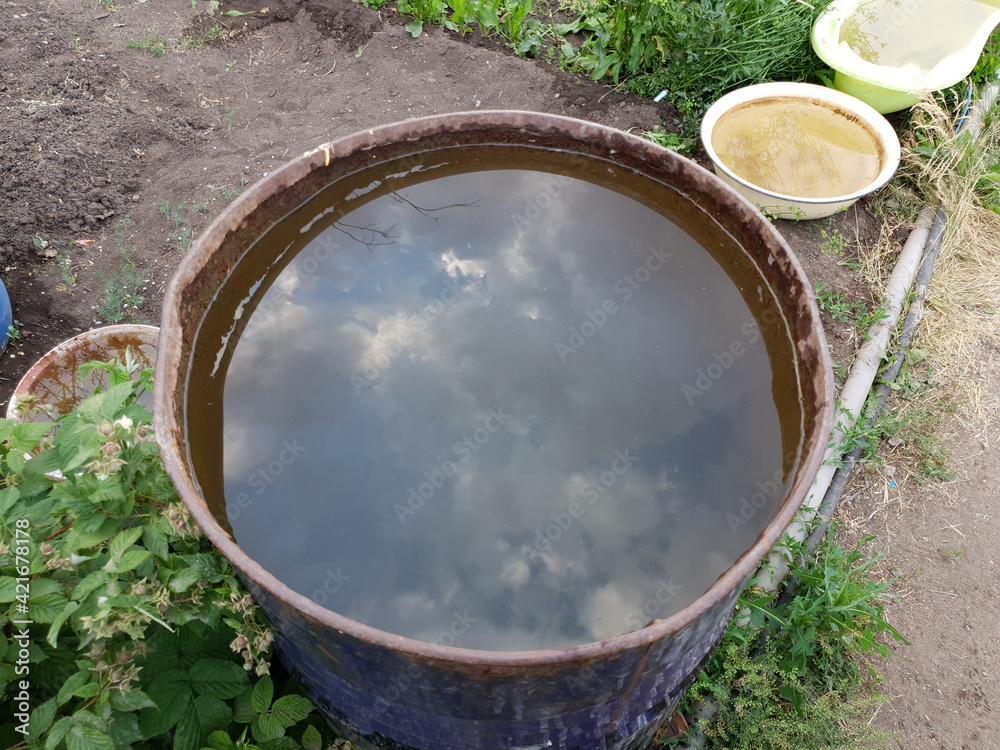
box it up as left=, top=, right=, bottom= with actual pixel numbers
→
left=712, top=98, right=882, bottom=198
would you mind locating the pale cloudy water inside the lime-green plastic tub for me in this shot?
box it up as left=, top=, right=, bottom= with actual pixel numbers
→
left=840, top=0, right=1000, bottom=75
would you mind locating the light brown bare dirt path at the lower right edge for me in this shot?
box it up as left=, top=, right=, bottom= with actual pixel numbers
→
left=842, top=360, right=1000, bottom=750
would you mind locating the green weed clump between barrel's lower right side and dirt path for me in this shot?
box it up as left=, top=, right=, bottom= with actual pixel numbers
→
left=684, top=538, right=905, bottom=750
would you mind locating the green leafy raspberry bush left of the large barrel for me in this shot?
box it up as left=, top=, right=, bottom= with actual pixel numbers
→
left=0, top=356, right=342, bottom=750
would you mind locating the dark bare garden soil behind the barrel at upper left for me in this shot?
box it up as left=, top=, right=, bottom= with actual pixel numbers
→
left=0, top=0, right=676, bottom=408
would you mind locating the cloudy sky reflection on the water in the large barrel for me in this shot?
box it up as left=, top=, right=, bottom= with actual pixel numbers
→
left=224, top=170, right=784, bottom=650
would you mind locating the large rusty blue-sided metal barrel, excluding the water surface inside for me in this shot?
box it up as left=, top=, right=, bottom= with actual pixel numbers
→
left=154, top=112, right=833, bottom=750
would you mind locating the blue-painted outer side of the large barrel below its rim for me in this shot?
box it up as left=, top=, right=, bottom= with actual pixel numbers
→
left=247, top=581, right=741, bottom=750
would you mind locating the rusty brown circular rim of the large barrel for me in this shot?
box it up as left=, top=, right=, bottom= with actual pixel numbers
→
left=153, top=110, right=834, bottom=676
